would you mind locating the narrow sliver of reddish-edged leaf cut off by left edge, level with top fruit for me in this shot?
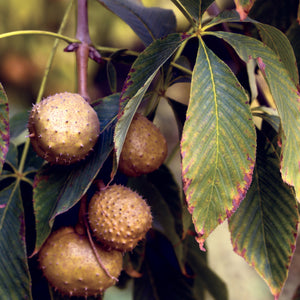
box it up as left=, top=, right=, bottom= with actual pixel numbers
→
left=0, top=83, right=9, bottom=174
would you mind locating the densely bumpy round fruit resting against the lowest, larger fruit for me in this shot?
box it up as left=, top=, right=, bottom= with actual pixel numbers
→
left=88, top=184, right=152, bottom=252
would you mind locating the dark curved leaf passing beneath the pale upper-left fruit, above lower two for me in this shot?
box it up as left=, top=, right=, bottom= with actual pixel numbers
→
left=33, top=94, right=120, bottom=252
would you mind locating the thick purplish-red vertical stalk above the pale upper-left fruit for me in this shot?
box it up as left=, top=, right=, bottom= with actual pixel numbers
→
left=76, top=0, right=91, bottom=102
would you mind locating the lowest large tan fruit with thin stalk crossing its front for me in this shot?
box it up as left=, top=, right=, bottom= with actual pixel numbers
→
left=39, top=227, right=123, bottom=297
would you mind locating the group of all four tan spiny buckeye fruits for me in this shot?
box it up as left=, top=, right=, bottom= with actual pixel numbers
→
left=28, top=93, right=167, bottom=297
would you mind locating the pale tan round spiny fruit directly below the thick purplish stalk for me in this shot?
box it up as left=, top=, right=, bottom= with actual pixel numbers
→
left=28, top=92, right=100, bottom=165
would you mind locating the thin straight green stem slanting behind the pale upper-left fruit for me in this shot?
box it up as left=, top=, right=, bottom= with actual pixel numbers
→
left=17, top=0, right=75, bottom=173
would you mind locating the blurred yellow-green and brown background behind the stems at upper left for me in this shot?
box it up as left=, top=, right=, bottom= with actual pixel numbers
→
left=0, top=0, right=187, bottom=115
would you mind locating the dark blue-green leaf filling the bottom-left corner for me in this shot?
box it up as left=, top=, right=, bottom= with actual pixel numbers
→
left=0, top=181, right=32, bottom=300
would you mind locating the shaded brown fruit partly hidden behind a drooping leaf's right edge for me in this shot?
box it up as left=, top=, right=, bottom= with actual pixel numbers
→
left=119, top=113, right=168, bottom=177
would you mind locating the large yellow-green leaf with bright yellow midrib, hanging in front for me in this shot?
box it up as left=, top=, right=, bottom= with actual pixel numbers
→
left=181, top=39, right=256, bottom=250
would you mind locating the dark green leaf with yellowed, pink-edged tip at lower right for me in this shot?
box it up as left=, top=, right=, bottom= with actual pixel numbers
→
left=229, top=126, right=299, bottom=299
